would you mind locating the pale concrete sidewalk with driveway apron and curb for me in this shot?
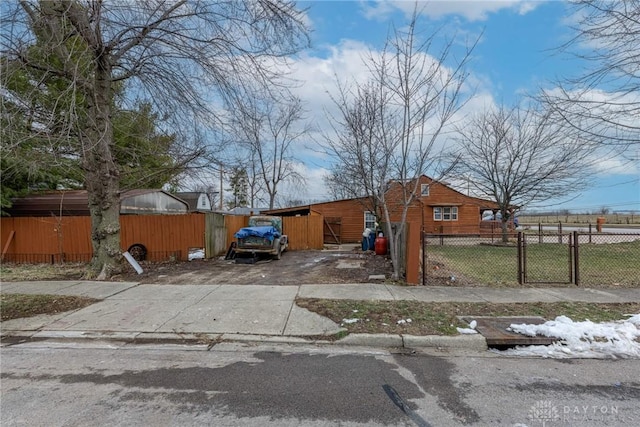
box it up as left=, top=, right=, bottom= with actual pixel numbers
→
left=0, top=281, right=640, bottom=348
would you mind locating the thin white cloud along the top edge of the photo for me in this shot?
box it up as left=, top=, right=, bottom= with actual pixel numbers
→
left=362, top=0, right=542, bottom=21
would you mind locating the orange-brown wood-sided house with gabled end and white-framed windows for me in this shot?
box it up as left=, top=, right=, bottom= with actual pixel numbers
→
left=264, top=175, right=498, bottom=244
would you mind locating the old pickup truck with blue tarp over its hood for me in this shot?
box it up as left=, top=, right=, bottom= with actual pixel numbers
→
left=235, top=215, right=289, bottom=259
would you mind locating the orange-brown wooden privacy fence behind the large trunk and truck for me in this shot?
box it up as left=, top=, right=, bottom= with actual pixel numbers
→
left=0, top=213, right=323, bottom=263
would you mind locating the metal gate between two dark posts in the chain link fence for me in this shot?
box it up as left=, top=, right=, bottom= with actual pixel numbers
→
left=518, top=233, right=577, bottom=284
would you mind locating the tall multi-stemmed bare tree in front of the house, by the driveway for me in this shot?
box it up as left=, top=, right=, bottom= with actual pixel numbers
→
left=324, top=7, right=472, bottom=279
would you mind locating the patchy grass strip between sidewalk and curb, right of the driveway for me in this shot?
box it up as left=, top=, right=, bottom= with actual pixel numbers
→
left=296, top=298, right=640, bottom=335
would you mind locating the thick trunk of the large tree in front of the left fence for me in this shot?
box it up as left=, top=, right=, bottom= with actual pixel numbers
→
left=83, top=57, right=122, bottom=280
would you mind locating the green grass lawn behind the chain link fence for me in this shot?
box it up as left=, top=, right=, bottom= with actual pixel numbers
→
left=427, top=241, right=640, bottom=286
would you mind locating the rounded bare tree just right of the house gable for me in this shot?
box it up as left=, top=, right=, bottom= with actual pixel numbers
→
left=456, top=101, right=591, bottom=242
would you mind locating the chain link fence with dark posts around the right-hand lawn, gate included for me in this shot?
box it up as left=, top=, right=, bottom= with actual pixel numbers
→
left=422, top=231, right=640, bottom=287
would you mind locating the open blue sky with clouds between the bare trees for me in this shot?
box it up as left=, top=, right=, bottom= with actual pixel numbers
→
left=272, top=0, right=640, bottom=212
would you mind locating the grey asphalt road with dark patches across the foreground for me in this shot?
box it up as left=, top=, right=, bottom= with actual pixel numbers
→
left=0, top=341, right=640, bottom=427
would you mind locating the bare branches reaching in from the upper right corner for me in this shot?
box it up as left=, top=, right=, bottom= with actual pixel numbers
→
left=540, top=0, right=640, bottom=154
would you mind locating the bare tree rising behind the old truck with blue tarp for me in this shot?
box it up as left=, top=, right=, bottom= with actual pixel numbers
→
left=232, top=95, right=309, bottom=209
